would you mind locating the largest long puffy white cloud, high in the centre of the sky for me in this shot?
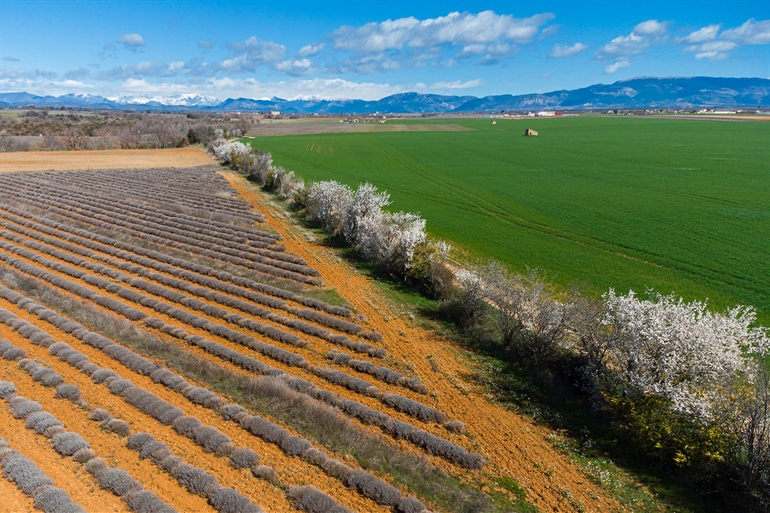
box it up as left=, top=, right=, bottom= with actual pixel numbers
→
left=330, top=11, right=554, bottom=52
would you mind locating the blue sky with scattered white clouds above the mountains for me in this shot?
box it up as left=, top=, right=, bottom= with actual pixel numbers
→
left=0, top=0, right=770, bottom=99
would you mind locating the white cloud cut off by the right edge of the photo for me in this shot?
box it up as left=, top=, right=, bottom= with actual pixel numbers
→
left=677, top=18, right=770, bottom=60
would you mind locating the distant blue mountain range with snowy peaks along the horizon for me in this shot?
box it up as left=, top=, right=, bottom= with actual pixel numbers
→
left=0, top=77, right=770, bottom=114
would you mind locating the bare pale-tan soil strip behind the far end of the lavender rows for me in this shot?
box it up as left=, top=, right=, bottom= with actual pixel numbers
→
left=0, top=148, right=213, bottom=173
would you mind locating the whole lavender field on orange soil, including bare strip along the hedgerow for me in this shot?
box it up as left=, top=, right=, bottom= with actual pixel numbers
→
left=0, top=152, right=621, bottom=513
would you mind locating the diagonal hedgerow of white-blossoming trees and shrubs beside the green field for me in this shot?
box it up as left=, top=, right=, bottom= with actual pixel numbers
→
left=210, top=139, right=770, bottom=511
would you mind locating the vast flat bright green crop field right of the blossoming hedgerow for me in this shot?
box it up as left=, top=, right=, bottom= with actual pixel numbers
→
left=249, top=117, right=770, bottom=325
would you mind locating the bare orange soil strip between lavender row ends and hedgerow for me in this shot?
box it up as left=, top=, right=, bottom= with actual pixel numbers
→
left=221, top=172, right=624, bottom=512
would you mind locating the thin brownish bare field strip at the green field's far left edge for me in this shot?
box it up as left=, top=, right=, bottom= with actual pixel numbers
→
left=248, top=120, right=472, bottom=137
